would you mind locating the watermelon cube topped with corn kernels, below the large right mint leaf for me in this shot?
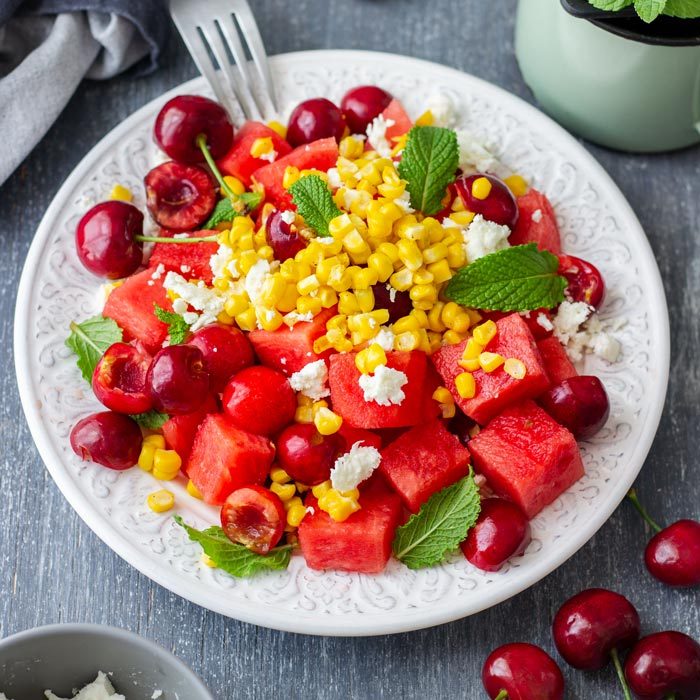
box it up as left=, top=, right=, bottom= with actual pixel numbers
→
left=432, top=314, right=549, bottom=425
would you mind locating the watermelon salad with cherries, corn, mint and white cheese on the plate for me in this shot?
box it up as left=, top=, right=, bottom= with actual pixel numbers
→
left=66, top=86, right=620, bottom=576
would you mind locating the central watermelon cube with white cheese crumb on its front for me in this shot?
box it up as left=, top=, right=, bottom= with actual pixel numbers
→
left=328, top=350, right=435, bottom=430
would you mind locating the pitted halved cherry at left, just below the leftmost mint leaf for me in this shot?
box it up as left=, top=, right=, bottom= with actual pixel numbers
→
left=92, top=343, right=153, bottom=413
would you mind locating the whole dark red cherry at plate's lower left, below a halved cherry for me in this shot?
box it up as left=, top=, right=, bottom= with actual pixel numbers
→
left=70, top=411, right=143, bottom=471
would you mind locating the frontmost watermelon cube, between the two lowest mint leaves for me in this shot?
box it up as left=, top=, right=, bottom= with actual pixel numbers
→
left=299, top=477, right=401, bottom=574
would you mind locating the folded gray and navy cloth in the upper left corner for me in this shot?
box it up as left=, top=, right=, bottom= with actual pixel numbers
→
left=0, top=0, right=169, bottom=184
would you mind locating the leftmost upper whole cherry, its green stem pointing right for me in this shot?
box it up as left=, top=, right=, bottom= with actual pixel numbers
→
left=75, top=200, right=143, bottom=280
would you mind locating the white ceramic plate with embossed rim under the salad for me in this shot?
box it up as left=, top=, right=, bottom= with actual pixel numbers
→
left=15, top=51, right=669, bottom=636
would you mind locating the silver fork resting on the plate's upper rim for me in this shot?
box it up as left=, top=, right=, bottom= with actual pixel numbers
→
left=170, top=0, right=277, bottom=120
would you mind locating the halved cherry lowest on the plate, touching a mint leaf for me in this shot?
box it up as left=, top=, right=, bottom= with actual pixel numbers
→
left=221, top=486, right=287, bottom=554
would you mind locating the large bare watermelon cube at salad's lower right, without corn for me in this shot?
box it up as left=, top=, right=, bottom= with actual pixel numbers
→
left=469, top=401, right=583, bottom=518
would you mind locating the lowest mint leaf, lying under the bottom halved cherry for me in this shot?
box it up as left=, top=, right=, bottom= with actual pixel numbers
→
left=175, top=515, right=292, bottom=578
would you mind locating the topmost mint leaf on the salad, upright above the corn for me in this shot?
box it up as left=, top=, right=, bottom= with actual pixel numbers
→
left=399, top=126, right=459, bottom=216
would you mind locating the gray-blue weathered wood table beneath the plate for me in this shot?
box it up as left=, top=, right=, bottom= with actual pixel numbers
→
left=0, top=0, right=700, bottom=700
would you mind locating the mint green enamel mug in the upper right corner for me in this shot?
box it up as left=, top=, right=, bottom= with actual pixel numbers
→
left=515, top=0, right=700, bottom=152
